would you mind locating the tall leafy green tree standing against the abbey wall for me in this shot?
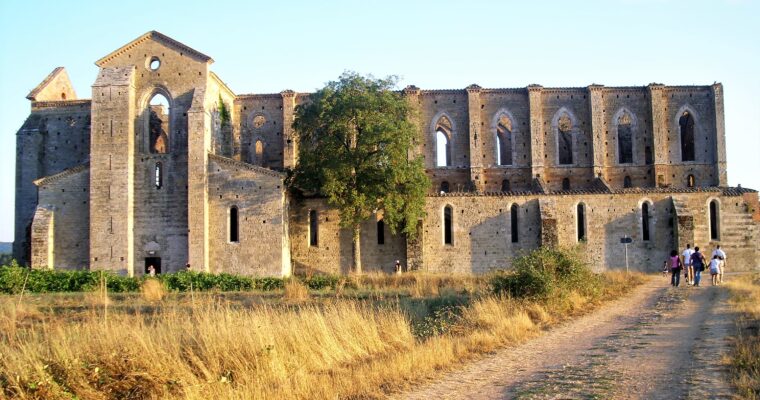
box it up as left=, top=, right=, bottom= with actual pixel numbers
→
left=290, top=72, right=430, bottom=273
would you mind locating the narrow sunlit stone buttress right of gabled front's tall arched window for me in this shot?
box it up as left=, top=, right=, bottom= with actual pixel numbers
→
left=187, top=88, right=212, bottom=272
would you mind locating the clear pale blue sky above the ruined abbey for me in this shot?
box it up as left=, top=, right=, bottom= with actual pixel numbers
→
left=0, top=0, right=760, bottom=241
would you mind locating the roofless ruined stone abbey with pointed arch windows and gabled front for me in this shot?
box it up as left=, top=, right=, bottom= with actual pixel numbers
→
left=14, top=31, right=760, bottom=276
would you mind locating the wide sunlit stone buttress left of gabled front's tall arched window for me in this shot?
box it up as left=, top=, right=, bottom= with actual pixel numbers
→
left=90, top=66, right=137, bottom=276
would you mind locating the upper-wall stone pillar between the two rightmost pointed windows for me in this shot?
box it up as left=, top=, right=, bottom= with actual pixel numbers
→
left=647, top=83, right=671, bottom=186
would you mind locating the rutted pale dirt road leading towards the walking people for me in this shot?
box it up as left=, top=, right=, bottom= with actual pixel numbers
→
left=399, top=276, right=732, bottom=399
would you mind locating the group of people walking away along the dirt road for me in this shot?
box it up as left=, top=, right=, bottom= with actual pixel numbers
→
left=663, top=244, right=726, bottom=287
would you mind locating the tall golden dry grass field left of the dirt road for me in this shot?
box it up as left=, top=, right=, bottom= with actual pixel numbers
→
left=0, top=274, right=636, bottom=399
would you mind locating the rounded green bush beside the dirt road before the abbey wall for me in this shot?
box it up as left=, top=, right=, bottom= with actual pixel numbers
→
left=489, top=247, right=599, bottom=299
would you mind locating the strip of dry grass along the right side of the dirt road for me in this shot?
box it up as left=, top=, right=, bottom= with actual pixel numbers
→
left=727, top=277, right=760, bottom=399
